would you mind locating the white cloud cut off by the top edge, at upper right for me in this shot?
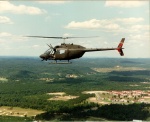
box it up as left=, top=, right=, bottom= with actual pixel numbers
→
left=105, top=1, right=147, bottom=8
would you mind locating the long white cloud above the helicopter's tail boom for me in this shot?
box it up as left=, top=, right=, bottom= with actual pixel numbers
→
left=65, top=17, right=144, bottom=30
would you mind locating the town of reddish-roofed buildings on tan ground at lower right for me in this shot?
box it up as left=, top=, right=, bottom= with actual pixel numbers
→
left=83, top=90, right=150, bottom=104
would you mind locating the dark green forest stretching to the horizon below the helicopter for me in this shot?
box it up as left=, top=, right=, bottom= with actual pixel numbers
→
left=0, top=57, right=150, bottom=121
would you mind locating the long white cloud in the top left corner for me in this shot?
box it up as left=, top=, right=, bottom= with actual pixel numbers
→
left=0, top=1, right=46, bottom=15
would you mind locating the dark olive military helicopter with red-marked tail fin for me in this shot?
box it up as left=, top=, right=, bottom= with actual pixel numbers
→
left=27, top=36, right=125, bottom=63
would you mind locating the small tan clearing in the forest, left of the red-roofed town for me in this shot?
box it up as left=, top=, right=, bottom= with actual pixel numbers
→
left=47, top=92, right=79, bottom=101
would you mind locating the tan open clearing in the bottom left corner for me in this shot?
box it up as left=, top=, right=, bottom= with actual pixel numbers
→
left=0, top=106, right=44, bottom=117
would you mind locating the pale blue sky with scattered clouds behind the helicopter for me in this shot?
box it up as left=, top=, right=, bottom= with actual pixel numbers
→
left=0, top=0, right=150, bottom=58
